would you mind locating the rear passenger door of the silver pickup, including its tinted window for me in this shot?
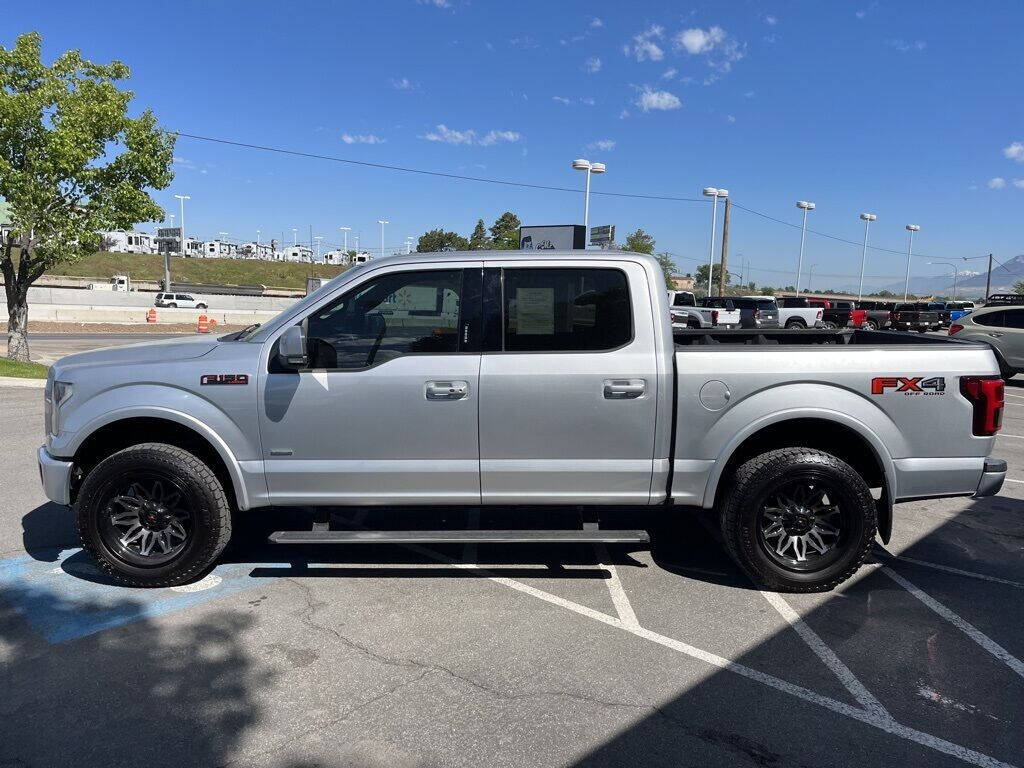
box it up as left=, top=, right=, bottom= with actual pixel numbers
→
left=480, top=260, right=669, bottom=504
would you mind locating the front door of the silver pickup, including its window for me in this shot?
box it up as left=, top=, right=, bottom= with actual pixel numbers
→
left=253, top=262, right=481, bottom=505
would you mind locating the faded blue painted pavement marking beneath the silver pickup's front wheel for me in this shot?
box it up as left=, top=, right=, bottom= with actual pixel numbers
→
left=0, top=549, right=276, bottom=643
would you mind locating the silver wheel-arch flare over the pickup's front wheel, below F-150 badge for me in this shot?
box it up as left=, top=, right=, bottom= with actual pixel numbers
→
left=51, top=384, right=262, bottom=509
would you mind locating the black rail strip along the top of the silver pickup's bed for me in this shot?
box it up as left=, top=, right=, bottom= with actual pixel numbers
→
left=672, top=328, right=961, bottom=348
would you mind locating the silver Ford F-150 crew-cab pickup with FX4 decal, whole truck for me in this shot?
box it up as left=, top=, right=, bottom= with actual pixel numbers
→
left=39, top=251, right=1006, bottom=591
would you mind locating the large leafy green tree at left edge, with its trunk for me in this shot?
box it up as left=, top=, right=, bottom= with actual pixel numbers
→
left=0, top=32, right=174, bottom=360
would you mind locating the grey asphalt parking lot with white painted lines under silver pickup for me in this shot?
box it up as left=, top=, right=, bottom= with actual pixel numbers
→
left=0, top=364, right=1024, bottom=767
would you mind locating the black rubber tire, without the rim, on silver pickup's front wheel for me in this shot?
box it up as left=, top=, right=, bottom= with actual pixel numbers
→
left=75, top=442, right=231, bottom=587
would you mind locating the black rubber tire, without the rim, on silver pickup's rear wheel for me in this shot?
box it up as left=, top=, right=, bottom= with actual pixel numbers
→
left=720, top=447, right=877, bottom=592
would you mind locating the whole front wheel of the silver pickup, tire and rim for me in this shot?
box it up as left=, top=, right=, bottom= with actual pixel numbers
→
left=76, top=442, right=231, bottom=587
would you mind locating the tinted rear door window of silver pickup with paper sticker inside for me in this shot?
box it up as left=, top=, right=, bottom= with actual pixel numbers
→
left=503, top=267, right=633, bottom=352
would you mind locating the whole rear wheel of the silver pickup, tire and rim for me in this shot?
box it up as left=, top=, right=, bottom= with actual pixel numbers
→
left=721, top=447, right=877, bottom=592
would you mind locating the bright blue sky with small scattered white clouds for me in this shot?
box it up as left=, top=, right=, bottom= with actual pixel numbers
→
left=8, top=0, right=1024, bottom=288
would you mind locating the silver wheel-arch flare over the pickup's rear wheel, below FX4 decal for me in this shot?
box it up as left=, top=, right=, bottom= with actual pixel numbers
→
left=701, top=383, right=906, bottom=508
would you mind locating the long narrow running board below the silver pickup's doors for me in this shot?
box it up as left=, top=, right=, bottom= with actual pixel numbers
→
left=269, top=529, right=650, bottom=544
